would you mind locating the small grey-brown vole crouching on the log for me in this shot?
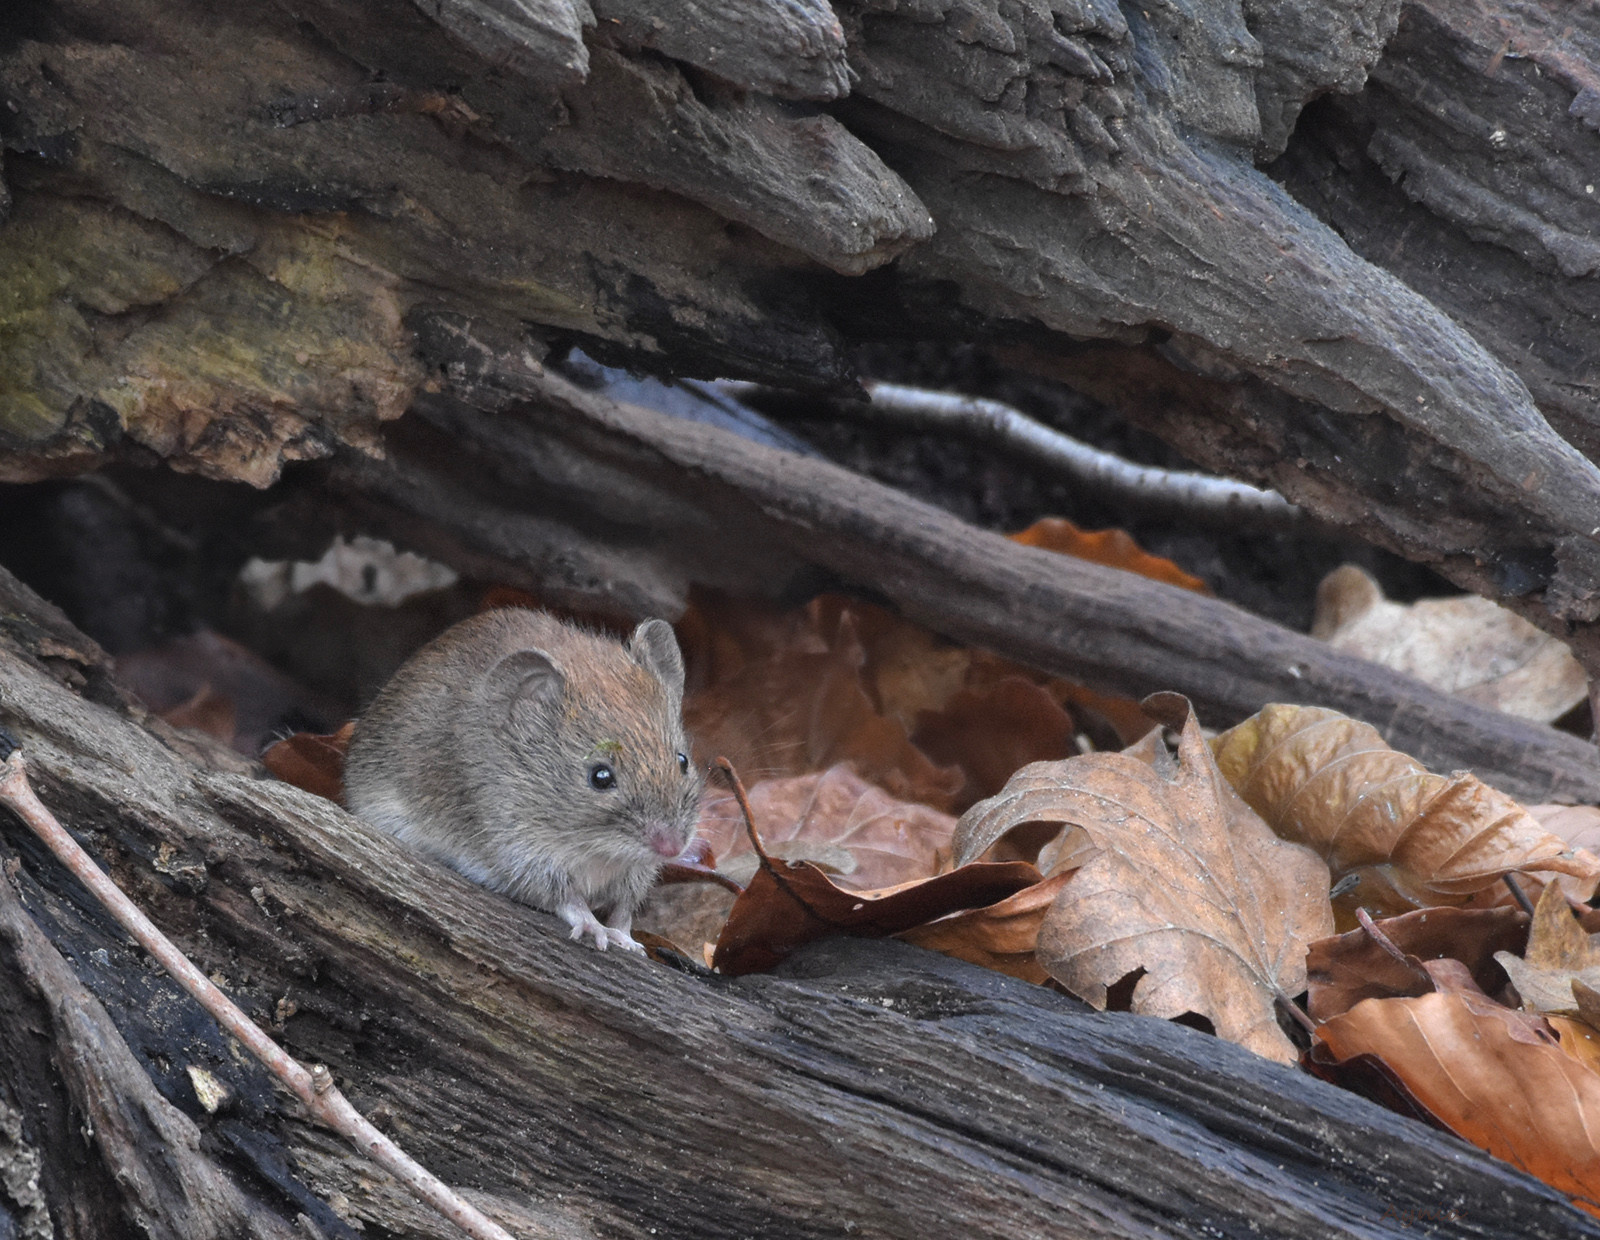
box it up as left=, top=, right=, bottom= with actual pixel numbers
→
left=344, top=608, right=701, bottom=950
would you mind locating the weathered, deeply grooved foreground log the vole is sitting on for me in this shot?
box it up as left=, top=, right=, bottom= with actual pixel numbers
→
left=0, top=574, right=1600, bottom=1240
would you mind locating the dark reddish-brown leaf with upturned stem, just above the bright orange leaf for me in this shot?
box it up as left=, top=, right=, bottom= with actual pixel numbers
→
left=1306, top=909, right=1528, bottom=1021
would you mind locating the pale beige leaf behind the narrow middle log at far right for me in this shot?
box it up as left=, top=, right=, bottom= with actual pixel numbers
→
left=1312, top=565, right=1589, bottom=723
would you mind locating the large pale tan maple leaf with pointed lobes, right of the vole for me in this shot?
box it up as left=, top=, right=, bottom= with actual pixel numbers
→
left=955, top=702, right=1333, bottom=1062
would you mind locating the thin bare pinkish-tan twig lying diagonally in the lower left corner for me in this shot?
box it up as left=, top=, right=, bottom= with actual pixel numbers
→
left=0, top=734, right=512, bottom=1240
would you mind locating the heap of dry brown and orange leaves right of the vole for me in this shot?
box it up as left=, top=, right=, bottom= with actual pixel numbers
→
left=240, top=526, right=1600, bottom=1211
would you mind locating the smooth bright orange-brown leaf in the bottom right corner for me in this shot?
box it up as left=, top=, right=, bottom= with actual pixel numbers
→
left=1314, top=992, right=1600, bottom=1214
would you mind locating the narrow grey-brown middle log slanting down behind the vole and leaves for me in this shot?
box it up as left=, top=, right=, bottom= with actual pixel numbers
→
left=288, top=333, right=1600, bottom=800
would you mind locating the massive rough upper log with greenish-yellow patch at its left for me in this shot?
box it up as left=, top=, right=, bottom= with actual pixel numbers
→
left=0, top=0, right=1600, bottom=669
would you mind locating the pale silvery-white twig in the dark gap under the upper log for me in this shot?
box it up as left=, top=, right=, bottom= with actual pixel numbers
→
left=717, top=379, right=1304, bottom=528
